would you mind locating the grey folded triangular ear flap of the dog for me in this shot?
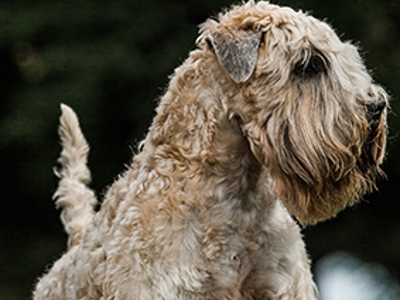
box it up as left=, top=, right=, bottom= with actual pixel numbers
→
left=206, top=30, right=263, bottom=83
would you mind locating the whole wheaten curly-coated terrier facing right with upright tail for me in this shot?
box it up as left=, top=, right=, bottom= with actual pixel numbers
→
left=34, top=1, right=387, bottom=300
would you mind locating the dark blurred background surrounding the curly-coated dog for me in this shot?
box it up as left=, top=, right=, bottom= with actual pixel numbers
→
left=0, top=0, right=400, bottom=300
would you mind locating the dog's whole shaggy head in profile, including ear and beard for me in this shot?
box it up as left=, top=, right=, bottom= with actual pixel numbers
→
left=200, top=1, right=387, bottom=224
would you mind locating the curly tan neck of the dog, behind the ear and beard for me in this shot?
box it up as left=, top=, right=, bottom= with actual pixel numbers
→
left=135, top=50, right=262, bottom=207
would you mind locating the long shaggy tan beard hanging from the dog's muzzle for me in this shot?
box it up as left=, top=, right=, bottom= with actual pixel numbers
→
left=239, top=85, right=386, bottom=225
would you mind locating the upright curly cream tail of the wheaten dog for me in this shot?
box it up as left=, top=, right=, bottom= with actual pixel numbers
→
left=53, top=104, right=97, bottom=248
